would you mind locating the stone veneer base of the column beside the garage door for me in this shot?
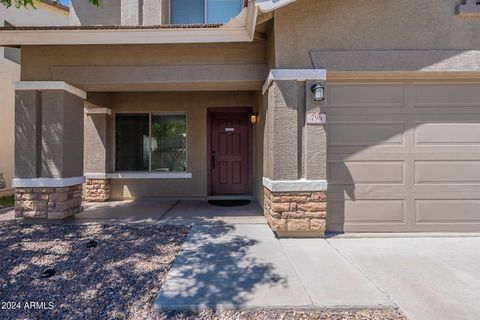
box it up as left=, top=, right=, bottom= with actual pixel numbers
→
left=264, top=188, right=327, bottom=238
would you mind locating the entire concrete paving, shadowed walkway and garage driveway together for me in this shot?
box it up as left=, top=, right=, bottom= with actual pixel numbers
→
left=155, top=225, right=480, bottom=320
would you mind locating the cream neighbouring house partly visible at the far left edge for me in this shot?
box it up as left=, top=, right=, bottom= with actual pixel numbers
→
left=0, top=1, right=69, bottom=197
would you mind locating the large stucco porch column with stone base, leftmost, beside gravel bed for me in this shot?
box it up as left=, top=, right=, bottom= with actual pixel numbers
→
left=12, top=81, right=86, bottom=219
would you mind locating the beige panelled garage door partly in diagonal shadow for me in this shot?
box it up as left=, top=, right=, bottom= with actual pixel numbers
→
left=327, top=81, right=480, bottom=232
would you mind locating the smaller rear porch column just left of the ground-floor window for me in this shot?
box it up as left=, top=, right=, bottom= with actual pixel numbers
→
left=84, top=106, right=112, bottom=202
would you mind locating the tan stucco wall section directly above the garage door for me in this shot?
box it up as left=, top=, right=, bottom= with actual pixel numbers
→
left=275, top=0, right=480, bottom=68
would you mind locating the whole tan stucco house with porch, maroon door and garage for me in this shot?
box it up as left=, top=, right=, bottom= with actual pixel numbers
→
left=0, top=0, right=480, bottom=237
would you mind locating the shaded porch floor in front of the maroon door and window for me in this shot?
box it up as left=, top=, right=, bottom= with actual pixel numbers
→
left=72, top=199, right=266, bottom=224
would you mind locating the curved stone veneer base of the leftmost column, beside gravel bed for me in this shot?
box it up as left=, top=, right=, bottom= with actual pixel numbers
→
left=15, top=184, right=83, bottom=219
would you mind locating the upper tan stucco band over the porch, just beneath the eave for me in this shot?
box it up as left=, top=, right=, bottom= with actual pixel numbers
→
left=22, top=42, right=266, bottom=80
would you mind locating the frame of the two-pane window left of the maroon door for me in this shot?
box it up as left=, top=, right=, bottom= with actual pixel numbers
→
left=111, top=110, right=191, bottom=178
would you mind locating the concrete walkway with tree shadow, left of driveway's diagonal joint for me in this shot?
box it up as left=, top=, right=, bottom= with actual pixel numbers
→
left=155, top=225, right=394, bottom=309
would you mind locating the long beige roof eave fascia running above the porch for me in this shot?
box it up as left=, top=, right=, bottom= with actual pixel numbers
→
left=0, top=1, right=258, bottom=46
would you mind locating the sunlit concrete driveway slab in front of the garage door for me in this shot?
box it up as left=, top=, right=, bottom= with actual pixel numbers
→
left=328, top=237, right=480, bottom=320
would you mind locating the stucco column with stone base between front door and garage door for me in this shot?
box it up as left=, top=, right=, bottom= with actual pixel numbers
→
left=263, top=69, right=327, bottom=237
